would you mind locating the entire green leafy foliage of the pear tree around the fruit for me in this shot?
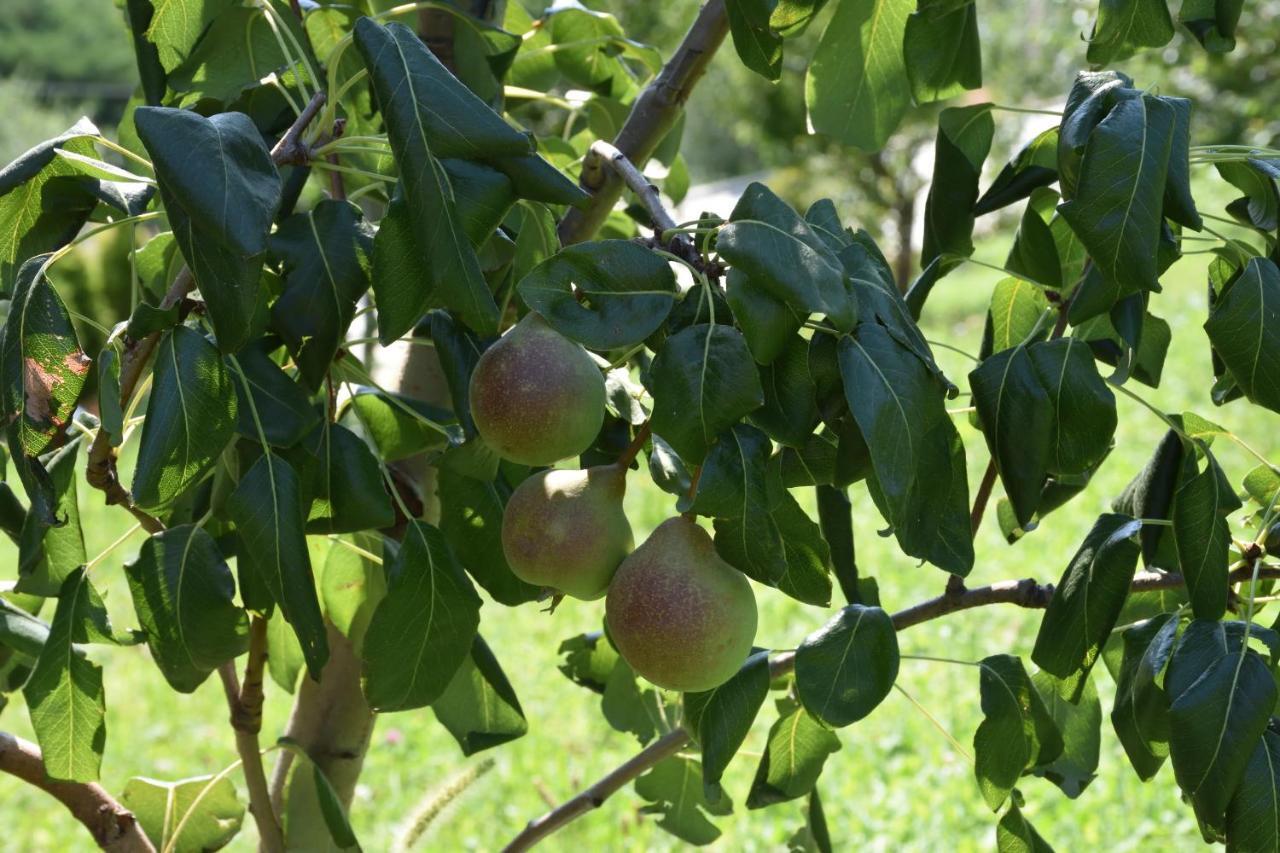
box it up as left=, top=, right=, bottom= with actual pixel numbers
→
left=0, top=0, right=1280, bottom=849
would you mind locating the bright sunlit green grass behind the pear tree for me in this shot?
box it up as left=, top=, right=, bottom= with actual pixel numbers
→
left=0, top=227, right=1280, bottom=850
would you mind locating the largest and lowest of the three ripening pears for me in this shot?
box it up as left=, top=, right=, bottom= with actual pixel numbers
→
left=604, top=516, right=755, bottom=692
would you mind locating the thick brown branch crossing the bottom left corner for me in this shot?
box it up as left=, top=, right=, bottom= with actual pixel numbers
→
left=0, top=731, right=155, bottom=853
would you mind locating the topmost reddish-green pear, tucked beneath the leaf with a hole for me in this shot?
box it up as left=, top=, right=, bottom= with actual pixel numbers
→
left=471, top=313, right=604, bottom=465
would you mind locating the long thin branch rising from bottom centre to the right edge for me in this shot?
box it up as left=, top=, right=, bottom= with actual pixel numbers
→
left=503, top=566, right=1280, bottom=853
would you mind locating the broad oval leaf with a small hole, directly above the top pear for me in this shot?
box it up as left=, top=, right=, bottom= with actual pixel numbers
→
left=517, top=240, right=678, bottom=351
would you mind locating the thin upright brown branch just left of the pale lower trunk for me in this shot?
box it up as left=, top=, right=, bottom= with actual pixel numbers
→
left=218, top=616, right=284, bottom=853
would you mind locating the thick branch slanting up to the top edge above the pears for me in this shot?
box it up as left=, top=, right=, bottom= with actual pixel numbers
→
left=559, top=0, right=728, bottom=246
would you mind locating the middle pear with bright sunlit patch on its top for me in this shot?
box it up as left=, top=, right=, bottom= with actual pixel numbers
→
left=502, top=465, right=635, bottom=601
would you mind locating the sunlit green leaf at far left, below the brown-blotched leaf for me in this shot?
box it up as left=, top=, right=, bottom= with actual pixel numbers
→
left=14, top=442, right=88, bottom=596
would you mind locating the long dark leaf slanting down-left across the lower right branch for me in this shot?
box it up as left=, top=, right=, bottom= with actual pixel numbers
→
left=1032, top=514, right=1142, bottom=702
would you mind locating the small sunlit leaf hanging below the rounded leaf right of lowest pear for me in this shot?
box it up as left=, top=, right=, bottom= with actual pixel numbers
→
left=746, top=699, right=840, bottom=808
